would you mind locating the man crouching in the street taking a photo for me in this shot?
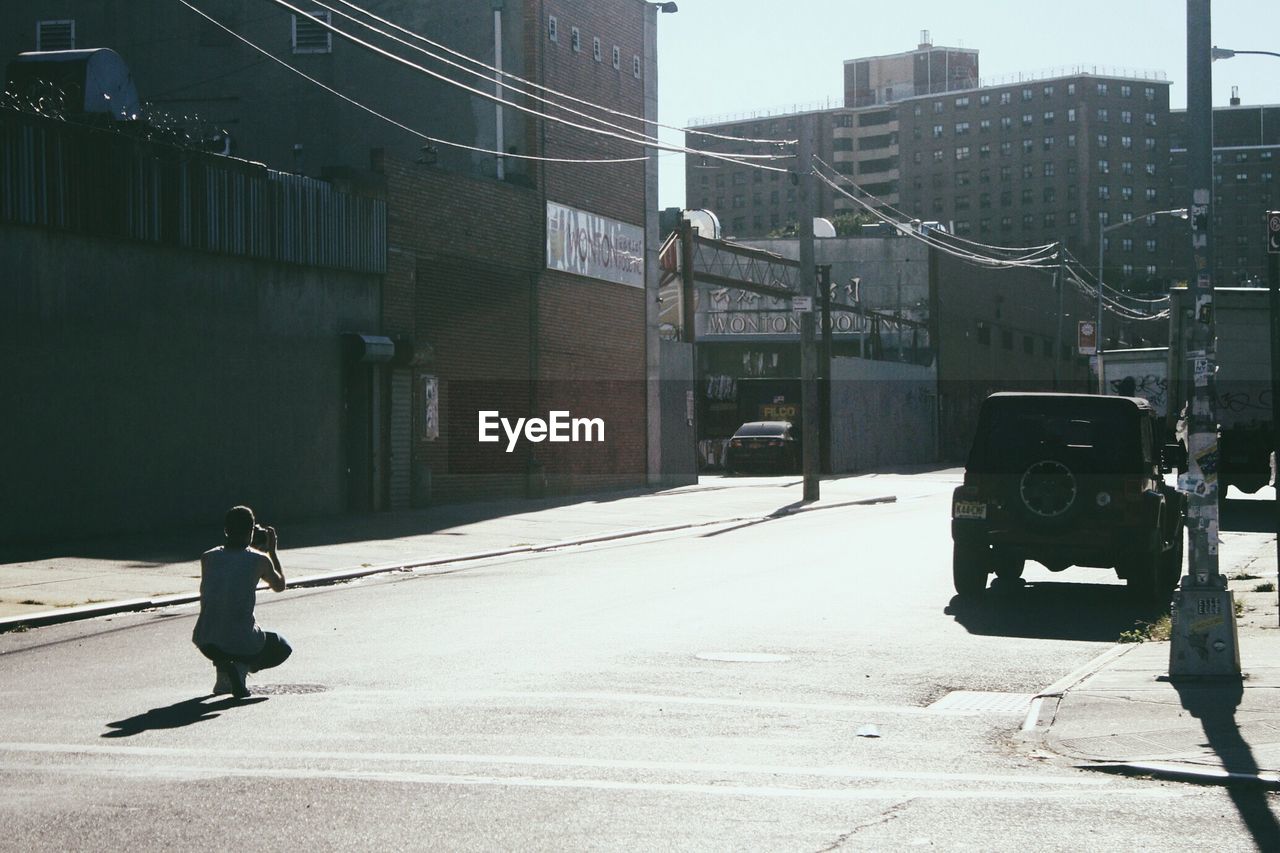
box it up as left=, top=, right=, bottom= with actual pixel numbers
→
left=191, top=506, right=293, bottom=699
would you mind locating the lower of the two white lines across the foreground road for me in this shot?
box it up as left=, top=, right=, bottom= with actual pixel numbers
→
left=0, top=763, right=1184, bottom=802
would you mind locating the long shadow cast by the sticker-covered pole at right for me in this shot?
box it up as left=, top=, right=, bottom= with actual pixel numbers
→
left=1170, top=678, right=1280, bottom=850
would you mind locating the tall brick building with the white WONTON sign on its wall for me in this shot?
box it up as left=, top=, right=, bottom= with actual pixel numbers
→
left=0, top=0, right=678, bottom=507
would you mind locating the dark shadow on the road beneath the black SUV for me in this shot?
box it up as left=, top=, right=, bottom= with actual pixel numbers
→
left=943, top=581, right=1169, bottom=643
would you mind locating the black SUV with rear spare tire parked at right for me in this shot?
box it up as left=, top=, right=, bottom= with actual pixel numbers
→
left=951, top=393, right=1187, bottom=602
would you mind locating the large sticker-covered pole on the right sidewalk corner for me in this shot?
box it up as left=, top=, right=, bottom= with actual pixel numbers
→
left=1172, top=0, right=1240, bottom=678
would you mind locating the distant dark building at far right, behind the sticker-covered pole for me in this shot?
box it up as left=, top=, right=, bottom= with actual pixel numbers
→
left=1169, top=99, right=1280, bottom=287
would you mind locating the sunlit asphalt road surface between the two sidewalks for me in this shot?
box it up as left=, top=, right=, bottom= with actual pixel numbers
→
left=0, top=473, right=1275, bottom=850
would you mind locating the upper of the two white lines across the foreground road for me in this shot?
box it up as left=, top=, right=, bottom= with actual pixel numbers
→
left=0, top=743, right=1114, bottom=788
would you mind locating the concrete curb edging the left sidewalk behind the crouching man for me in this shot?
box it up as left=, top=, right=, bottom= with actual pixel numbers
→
left=0, top=494, right=897, bottom=634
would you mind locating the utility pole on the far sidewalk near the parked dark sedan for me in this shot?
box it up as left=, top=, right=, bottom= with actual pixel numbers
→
left=795, top=122, right=822, bottom=501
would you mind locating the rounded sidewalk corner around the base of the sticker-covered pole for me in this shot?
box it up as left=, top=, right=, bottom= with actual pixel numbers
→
left=1028, top=502, right=1280, bottom=789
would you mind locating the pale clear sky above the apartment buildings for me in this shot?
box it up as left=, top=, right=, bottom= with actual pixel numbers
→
left=658, top=0, right=1280, bottom=207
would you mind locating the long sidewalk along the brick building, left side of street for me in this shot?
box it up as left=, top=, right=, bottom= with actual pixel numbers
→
left=0, top=474, right=895, bottom=631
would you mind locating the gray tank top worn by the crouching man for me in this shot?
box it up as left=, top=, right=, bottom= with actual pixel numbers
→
left=191, top=547, right=266, bottom=654
